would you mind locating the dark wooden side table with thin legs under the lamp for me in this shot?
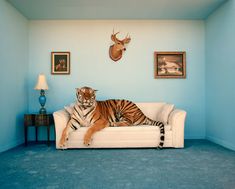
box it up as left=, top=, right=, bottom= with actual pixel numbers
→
left=24, top=114, right=54, bottom=146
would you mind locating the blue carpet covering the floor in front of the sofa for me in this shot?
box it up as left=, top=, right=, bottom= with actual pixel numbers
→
left=0, top=140, right=235, bottom=189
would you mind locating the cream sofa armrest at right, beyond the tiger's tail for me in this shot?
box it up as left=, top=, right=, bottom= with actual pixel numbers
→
left=168, top=109, right=187, bottom=148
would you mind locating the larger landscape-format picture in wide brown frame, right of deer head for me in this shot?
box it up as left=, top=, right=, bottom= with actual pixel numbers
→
left=154, top=52, right=186, bottom=78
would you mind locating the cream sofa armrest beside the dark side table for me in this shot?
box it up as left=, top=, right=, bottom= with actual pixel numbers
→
left=53, top=109, right=70, bottom=148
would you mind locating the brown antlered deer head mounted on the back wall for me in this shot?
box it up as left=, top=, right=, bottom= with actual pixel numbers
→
left=109, top=31, right=131, bottom=61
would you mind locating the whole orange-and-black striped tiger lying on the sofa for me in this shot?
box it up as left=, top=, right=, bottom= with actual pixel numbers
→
left=59, top=87, right=165, bottom=148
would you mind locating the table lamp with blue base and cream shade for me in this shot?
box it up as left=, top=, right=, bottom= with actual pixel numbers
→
left=34, top=74, right=48, bottom=114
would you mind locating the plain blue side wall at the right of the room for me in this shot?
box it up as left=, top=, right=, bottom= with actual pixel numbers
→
left=206, top=0, right=235, bottom=150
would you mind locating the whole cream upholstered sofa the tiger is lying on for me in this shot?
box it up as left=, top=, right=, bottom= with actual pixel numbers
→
left=53, top=102, right=186, bottom=149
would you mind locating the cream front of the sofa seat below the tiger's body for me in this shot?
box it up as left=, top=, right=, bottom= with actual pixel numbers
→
left=56, top=125, right=172, bottom=149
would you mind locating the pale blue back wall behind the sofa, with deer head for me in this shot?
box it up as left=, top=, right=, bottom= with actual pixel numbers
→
left=28, top=20, right=205, bottom=138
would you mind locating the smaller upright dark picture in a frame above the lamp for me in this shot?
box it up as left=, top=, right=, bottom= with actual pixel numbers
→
left=51, top=52, right=70, bottom=74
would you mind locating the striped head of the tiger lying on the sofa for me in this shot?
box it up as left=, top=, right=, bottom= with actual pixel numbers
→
left=76, top=87, right=97, bottom=108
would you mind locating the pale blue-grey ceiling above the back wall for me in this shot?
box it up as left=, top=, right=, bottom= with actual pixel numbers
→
left=8, top=0, right=227, bottom=19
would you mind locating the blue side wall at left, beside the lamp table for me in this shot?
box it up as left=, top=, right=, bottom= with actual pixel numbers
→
left=0, top=0, right=28, bottom=152
